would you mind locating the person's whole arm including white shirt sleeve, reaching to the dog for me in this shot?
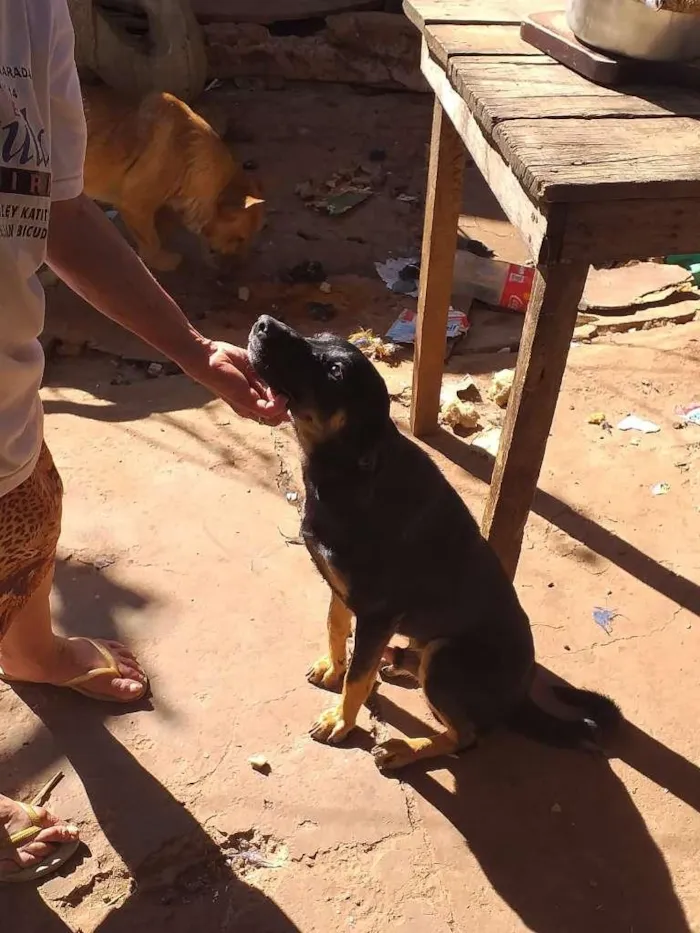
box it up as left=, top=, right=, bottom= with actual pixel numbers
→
left=47, top=0, right=286, bottom=424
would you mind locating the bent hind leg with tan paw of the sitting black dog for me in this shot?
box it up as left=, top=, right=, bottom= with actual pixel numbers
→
left=372, top=639, right=476, bottom=770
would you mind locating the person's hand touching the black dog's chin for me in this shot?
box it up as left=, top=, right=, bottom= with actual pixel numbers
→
left=186, top=340, right=289, bottom=425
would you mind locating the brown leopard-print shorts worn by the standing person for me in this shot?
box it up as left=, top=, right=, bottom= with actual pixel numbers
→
left=0, top=444, right=63, bottom=638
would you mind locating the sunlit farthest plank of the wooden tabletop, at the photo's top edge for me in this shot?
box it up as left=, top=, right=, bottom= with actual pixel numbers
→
left=403, top=0, right=563, bottom=32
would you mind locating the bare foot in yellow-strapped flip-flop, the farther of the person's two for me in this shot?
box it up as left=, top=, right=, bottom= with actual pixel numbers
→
left=0, top=630, right=148, bottom=703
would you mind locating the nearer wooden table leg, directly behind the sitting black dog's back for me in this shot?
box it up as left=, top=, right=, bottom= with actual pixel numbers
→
left=481, top=263, right=588, bottom=579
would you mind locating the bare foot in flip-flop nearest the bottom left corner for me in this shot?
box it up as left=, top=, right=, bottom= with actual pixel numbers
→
left=0, top=794, right=78, bottom=880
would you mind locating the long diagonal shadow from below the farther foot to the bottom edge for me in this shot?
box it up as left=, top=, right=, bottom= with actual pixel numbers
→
left=8, top=703, right=298, bottom=933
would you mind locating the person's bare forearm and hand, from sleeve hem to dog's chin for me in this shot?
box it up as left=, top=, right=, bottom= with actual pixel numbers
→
left=46, top=194, right=286, bottom=423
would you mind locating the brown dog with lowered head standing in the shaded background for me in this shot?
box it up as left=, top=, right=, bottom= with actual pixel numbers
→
left=83, top=85, right=264, bottom=271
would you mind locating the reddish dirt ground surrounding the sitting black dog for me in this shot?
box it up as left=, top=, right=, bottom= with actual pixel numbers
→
left=0, top=82, right=700, bottom=933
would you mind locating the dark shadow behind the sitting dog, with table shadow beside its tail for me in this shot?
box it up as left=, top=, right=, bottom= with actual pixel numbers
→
left=378, top=668, right=700, bottom=933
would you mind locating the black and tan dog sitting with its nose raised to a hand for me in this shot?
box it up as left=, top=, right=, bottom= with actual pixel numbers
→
left=248, top=316, right=620, bottom=768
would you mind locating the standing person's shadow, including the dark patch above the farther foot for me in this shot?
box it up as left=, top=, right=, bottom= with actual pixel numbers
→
left=0, top=559, right=299, bottom=933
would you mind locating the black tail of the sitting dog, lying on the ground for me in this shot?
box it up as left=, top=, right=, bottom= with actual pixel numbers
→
left=508, top=686, right=622, bottom=748
